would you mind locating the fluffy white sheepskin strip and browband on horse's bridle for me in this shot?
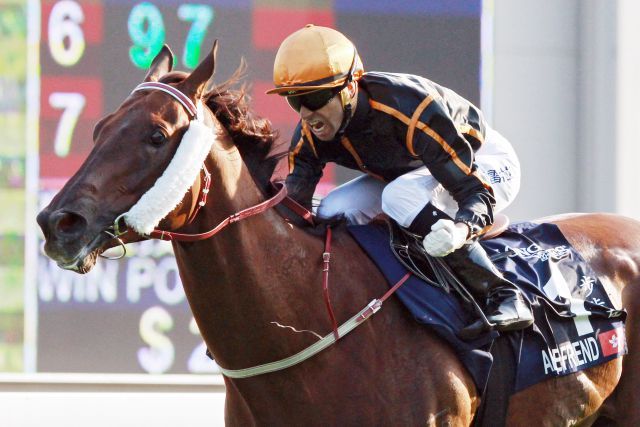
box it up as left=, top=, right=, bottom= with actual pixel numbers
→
left=124, top=82, right=215, bottom=235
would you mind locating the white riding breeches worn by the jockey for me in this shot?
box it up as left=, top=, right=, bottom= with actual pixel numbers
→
left=317, top=127, right=520, bottom=227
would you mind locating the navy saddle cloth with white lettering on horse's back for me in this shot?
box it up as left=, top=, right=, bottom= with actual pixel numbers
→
left=348, top=223, right=626, bottom=391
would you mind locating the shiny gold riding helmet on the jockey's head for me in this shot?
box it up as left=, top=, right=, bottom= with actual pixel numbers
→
left=267, top=24, right=364, bottom=98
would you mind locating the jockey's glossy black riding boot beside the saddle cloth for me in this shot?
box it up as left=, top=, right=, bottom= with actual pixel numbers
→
left=409, top=203, right=533, bottom=331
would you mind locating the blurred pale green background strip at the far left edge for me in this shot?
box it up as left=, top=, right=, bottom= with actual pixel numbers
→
left=0, top=0, right=27, bottom=372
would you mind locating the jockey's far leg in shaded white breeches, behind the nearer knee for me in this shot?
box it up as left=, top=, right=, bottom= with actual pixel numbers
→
left=317, top=175, right=385, bottom=224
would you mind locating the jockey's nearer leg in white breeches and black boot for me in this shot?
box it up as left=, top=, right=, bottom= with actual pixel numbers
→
left=382, top=129, right=533, bottom=330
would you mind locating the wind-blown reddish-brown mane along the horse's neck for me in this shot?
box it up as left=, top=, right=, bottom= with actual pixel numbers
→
left=161, top=65, right=288, bottom=191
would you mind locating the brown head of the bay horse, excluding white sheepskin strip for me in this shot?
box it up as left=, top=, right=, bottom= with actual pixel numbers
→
left=37, top=42, right=222, bottom=273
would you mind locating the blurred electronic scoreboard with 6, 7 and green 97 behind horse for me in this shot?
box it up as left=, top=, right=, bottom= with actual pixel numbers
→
left=32, top=0, right=482, bottom=373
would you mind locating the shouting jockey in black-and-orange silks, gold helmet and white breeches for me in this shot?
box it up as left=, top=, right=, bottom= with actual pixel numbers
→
left=267, top=25, right=533, bottom=331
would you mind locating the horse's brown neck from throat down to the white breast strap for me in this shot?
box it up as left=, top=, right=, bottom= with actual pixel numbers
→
left=174, top=135, right=326, bottom=368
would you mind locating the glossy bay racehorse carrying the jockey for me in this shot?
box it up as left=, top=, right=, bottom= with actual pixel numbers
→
left=38, top=45, right=640, bottom=426
